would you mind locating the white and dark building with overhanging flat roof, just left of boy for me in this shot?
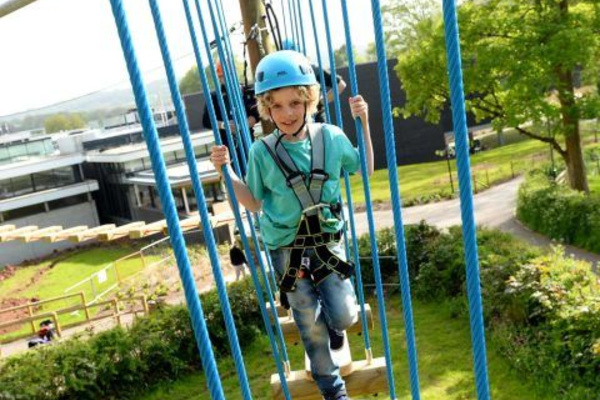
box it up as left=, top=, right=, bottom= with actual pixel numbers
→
left=83, top=125, right=224, bottom=224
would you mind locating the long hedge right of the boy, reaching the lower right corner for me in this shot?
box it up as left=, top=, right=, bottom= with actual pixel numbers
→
left=359, top=223, right=600, bottom=400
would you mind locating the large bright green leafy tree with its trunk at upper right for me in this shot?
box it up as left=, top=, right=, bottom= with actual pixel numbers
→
left=385, top=0, right=600, bottom=192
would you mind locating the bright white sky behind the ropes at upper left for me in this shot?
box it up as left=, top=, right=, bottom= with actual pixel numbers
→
left=0, top=0, right=374, bottom=117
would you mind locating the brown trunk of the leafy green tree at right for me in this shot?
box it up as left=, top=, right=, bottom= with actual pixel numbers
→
left=556, top=0, right=590, bottom=193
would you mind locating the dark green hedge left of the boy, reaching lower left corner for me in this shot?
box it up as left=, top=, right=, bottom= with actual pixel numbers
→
left=0, top=281, right=262, bottom=400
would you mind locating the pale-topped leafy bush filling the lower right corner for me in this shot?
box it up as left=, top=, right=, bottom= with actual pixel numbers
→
left=494, top=248, right=600, bottom=399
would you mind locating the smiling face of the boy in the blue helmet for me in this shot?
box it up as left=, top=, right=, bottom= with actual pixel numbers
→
left=270, top=87, right=306, bottom=135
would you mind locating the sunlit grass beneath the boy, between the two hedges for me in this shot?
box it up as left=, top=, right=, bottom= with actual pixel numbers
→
left=137, top=295, right=557, bottom=400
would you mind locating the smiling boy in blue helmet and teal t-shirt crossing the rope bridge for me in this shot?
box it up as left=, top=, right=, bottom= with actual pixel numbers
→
left=211, top=50, right=373, bottom=400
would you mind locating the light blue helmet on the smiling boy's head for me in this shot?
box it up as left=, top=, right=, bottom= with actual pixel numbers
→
left=254, top=50, right=317, bottom=95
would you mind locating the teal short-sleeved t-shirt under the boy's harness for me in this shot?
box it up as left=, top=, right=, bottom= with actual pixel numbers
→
left=246, top=124, right=360, bottom=249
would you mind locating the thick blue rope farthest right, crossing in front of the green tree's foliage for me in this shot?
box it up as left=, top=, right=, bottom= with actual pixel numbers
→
left=443, top=0, right=490, bottom=400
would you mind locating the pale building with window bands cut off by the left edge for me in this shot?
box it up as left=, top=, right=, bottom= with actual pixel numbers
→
left=0, top=132, right=99, bottom=265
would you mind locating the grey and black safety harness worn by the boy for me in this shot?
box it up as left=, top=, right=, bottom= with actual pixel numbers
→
left=262, top=124, right=354, bottom=292
